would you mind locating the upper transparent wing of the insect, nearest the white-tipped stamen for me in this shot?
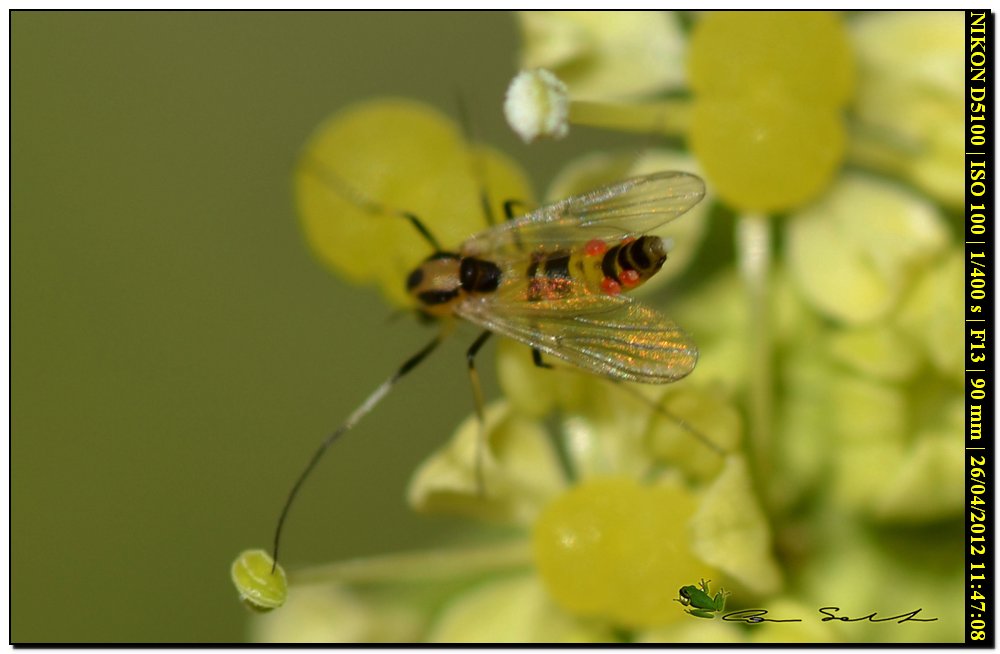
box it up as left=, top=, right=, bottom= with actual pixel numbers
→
left=461, top=171, right=705, bottom=257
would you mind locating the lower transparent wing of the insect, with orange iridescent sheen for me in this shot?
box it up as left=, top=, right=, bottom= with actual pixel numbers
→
left=456, top=295, right=698, bottom=384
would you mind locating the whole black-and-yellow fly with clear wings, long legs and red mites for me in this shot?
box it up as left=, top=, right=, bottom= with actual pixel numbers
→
left=273, top=170, right=717, bottom=561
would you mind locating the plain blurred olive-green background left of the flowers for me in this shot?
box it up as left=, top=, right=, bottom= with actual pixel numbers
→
left=11, top=12, right=620, bottom=643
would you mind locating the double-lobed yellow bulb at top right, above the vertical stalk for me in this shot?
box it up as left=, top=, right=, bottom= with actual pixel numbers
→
left=688, top=11, right=854, bottom=211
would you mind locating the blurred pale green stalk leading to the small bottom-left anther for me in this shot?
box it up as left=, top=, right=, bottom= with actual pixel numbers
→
left=289, top=540, right=532, bottom=584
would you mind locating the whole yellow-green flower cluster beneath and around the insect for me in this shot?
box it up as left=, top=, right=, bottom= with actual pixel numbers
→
left=238, top=12, right=964, bottom=642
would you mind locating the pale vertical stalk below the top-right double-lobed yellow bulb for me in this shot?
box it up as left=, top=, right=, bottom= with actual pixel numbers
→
left=736, top=213, right=774, bottom=505
